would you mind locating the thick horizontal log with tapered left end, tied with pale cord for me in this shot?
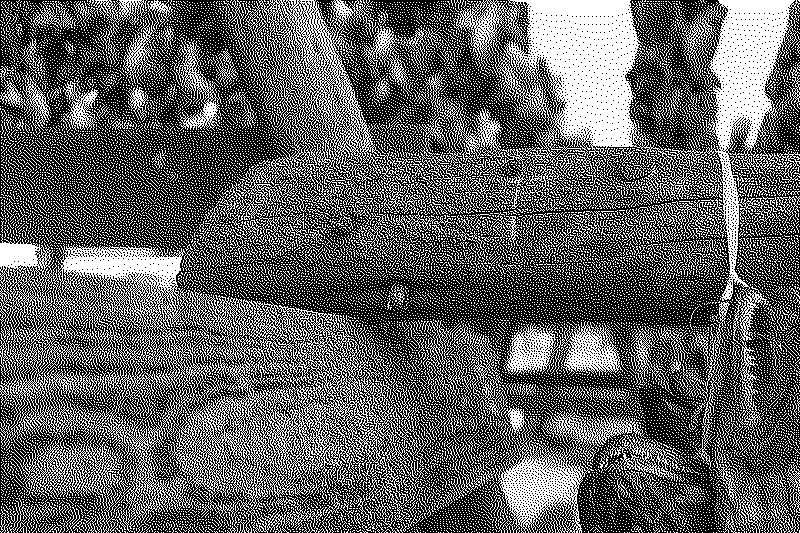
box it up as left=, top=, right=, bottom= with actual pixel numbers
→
left=178, top=148, right=800, bottom=324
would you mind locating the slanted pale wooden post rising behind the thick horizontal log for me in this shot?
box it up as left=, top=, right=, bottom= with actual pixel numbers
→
left=200, top=0, right=374, bottom=156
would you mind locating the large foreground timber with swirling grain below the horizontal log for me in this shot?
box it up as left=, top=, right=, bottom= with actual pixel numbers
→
left=0, top=269, right=510, bottom=531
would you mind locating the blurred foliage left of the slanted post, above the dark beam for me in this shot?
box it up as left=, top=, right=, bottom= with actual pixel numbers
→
left=0, top=0, right=247, bottom=129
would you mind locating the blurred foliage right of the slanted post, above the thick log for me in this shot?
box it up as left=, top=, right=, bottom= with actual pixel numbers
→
left=322, top=0, right=590, bottom=151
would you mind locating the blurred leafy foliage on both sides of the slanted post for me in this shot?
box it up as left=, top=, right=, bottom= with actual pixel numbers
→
left=0, top=0, right=590, bottom=151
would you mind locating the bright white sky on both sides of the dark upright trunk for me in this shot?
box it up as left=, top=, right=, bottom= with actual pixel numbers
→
left=523, top=0, right=791, bottom=147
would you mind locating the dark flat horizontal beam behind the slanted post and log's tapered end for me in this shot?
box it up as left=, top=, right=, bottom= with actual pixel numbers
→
left=0, top=126, right=432, bottom=249
